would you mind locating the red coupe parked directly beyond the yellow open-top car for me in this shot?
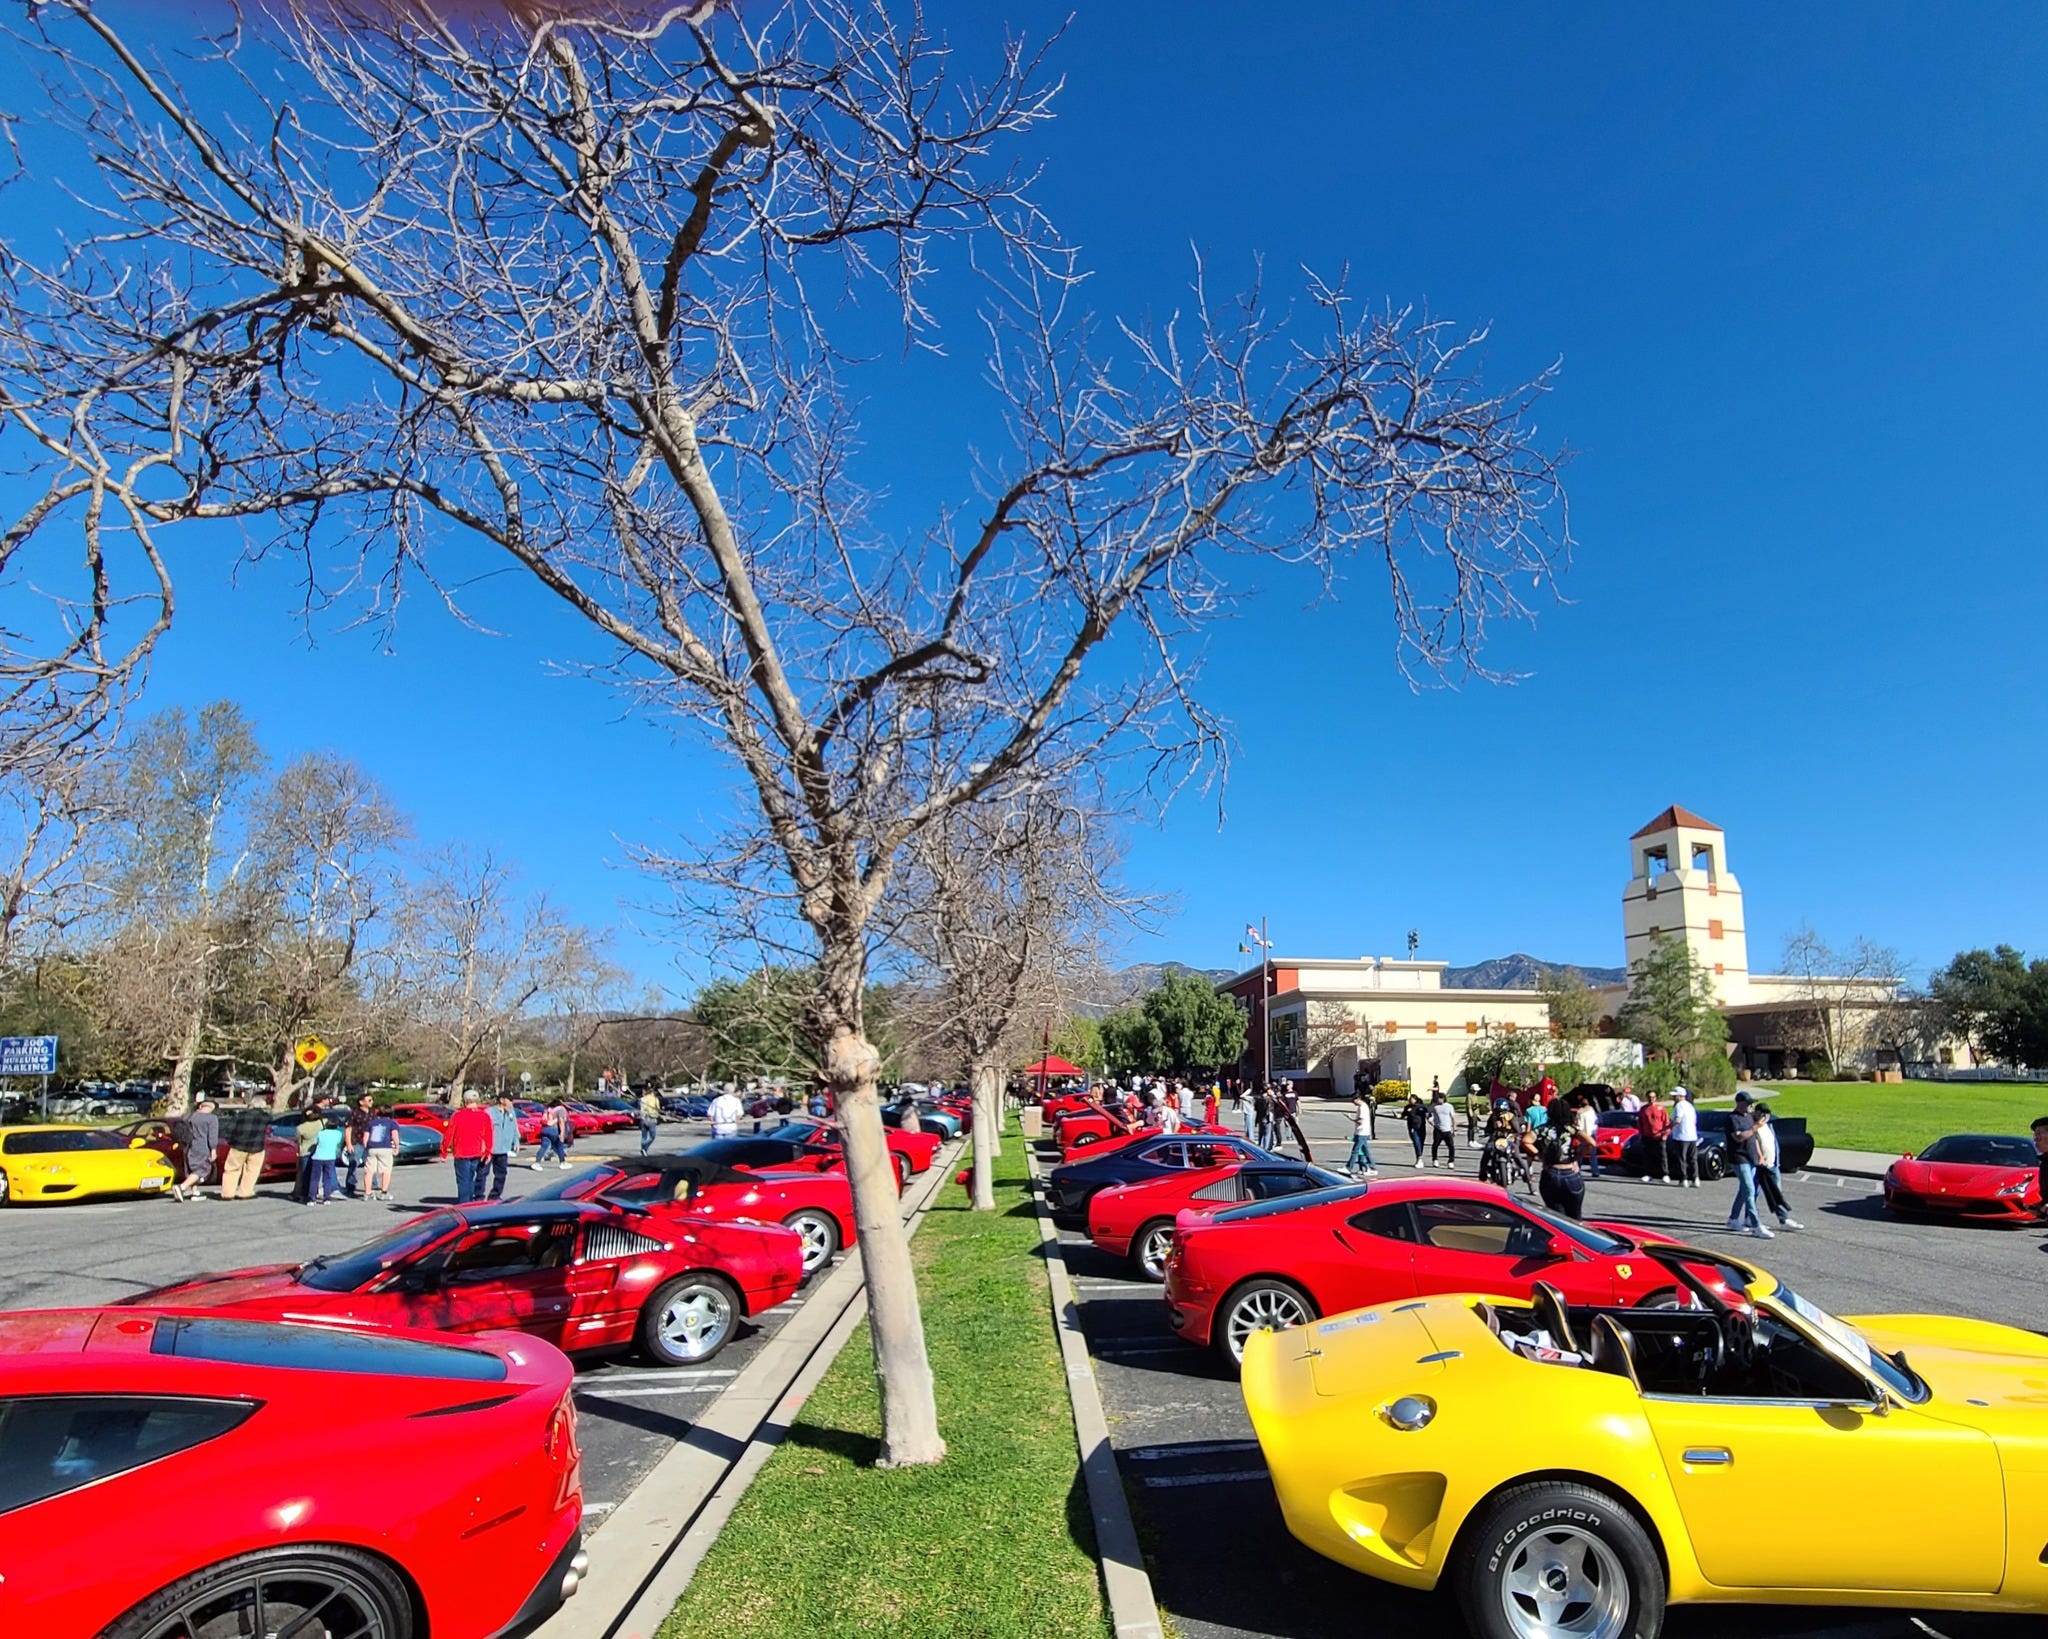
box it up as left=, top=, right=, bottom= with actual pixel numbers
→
left=1165, top=1178, right=1681, bottom=1364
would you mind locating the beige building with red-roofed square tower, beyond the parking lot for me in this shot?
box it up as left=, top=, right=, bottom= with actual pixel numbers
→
left=1219, top=803, right=1896, bottom=1094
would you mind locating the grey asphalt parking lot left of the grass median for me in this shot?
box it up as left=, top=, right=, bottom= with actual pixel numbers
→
left=0, top=1121, right=839, bottom=1516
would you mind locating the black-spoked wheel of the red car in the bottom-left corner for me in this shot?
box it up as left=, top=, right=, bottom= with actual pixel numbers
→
left=100, top=1547, right=420, bottom=1639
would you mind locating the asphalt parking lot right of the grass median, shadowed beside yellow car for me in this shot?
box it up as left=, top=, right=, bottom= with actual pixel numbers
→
left=1061, top=1106, right=2048, bottom=1639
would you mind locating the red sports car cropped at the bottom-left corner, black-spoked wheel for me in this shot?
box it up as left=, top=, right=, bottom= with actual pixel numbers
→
left=0, top=1307, right=588, bottom=1639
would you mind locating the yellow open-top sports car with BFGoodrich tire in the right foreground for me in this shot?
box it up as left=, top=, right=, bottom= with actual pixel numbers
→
left=1243, top=1246, right=2048, bottom=1639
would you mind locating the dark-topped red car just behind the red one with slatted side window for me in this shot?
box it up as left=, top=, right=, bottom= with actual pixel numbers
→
left=526, top=1155, right=854, bottom=1274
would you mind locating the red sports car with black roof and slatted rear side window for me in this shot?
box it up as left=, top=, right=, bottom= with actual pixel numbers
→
left=133, top=1201, right=803, bottom=1367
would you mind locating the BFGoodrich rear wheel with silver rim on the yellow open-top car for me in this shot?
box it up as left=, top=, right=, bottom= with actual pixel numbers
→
left=1450, top=1481, right=1665, bottom=1639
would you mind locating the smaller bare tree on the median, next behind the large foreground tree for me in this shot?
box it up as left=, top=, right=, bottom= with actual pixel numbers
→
left=901, top=789, right=1143, bottom=1211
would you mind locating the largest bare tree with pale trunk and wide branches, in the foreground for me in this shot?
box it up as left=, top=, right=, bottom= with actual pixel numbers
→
left=0, top=0, right=1565, bottom=1465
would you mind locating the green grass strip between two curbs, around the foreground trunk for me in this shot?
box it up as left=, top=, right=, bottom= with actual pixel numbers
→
left=659, top=1137, right=1108, bottom=1639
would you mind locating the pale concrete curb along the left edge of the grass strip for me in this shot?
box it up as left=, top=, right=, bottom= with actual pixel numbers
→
left=532, top=1141, right=958, bottom=1639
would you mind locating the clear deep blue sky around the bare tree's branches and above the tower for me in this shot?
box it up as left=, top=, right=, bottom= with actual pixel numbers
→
left=36, top=0, right=2048, bottom=983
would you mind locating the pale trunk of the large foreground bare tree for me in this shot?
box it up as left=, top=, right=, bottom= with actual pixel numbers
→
left=813, top=958, right=946, bottom=1469
